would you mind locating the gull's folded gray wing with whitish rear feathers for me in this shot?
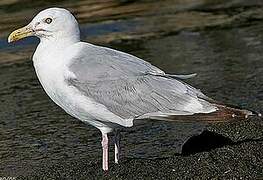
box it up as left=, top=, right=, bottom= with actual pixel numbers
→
left=67, top=44, right=218, bottom=119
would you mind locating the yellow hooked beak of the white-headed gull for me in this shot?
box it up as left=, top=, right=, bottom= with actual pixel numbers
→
left=8, top=25, right=34, bottom=43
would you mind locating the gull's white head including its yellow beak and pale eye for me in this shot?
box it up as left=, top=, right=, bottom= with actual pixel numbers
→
left=8, top=8, right=80, bottom=42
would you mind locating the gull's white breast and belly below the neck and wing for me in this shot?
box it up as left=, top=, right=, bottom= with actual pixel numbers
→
left=33, top=42, right=133, bottom=132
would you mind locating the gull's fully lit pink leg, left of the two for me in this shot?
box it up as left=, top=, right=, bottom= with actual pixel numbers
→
left=101, top=134, right=109, bottom=171
